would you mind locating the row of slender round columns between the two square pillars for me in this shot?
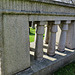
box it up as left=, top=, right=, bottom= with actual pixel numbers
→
left=35, top=20, right=71, bottom=60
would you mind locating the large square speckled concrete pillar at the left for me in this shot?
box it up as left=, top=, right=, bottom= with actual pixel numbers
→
left=2, top=15, right=30, bottom=75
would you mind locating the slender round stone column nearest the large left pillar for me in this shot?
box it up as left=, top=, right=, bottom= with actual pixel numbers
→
left=35, top=22, right=45, bottom=60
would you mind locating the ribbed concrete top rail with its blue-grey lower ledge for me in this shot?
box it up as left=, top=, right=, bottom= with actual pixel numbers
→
left=0, top=0, right=75, bottom=15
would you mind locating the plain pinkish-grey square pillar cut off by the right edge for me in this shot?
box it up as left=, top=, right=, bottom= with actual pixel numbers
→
left=66, top=21, right=75, bottom=49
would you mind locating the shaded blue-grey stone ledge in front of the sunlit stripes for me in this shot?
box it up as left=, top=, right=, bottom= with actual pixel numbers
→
left=16, top=52, right=75, bottom=75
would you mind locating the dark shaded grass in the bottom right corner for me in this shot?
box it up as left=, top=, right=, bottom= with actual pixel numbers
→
left=54, top=62, right=75, bottom=75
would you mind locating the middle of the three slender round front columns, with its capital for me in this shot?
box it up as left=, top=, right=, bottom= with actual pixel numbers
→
left=47, top=21, right=60, bottom=56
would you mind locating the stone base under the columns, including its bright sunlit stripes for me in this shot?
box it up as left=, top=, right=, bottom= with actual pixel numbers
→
left=16, top=43, right=75, bottom=75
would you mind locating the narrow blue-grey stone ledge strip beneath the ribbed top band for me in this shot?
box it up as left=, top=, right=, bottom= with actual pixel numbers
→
left=0, top=10, right=75, bottom=16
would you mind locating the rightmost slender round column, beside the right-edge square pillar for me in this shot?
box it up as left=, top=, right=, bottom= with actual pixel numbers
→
left=58, top=21, right=71, bottom=52
